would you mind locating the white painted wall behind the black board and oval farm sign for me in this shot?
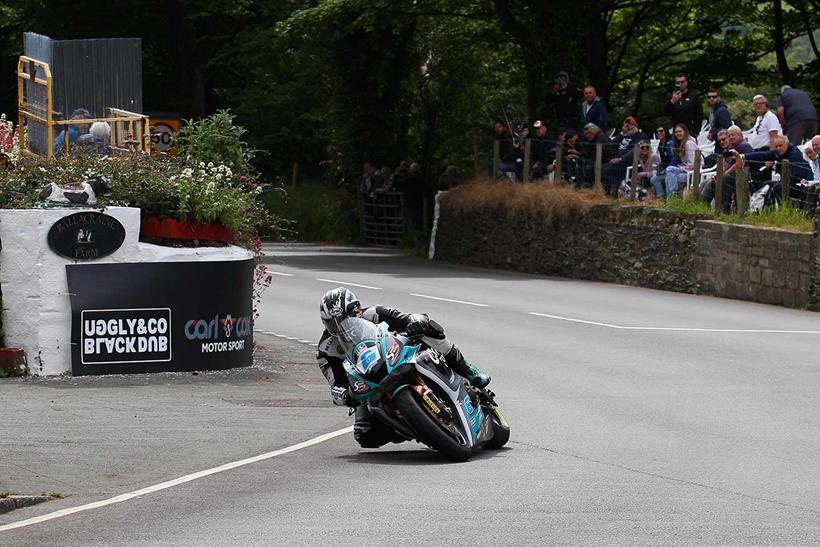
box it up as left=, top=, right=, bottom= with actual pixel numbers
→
left=0, top=207, right=253, bottom=376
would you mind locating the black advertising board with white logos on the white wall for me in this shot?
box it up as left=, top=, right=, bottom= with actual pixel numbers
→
left=66, top=259, right=254, bottom=375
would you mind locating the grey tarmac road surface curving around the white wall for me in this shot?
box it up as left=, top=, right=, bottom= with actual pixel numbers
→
left=0, top=245, right=820, bottom=545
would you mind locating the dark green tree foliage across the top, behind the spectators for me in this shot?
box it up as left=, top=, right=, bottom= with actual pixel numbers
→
left=0, top=0, right=820, bottom=186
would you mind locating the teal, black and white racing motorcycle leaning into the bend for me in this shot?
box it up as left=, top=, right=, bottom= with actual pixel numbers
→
left=339, top=317, right=510, bottom=461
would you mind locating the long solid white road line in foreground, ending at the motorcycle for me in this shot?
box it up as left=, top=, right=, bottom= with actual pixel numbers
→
left=0, top=426, right=353, bottom=532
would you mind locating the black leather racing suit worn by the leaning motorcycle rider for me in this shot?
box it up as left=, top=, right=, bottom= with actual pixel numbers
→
left=316, top=306, right=464, bottom=448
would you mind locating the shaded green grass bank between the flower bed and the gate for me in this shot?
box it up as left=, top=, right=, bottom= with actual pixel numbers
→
left=262, top=180, right=361, bottom=243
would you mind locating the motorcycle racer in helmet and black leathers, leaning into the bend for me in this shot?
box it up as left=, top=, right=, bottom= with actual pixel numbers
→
left=316, top=287, right=490, bottom=448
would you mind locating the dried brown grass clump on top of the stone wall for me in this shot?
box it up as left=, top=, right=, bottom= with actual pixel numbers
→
left=442, top=179, right=613, bottom=222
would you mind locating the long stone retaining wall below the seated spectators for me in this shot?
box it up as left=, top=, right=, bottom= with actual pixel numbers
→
left=435, top=204, right=820, bottom=310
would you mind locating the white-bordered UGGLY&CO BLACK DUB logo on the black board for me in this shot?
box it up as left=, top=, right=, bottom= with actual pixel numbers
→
left=80, top=308, right=171, bottom=365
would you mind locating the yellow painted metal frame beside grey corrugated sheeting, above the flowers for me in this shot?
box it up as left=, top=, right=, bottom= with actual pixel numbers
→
left=17, top=55, right=151, bottom=160
